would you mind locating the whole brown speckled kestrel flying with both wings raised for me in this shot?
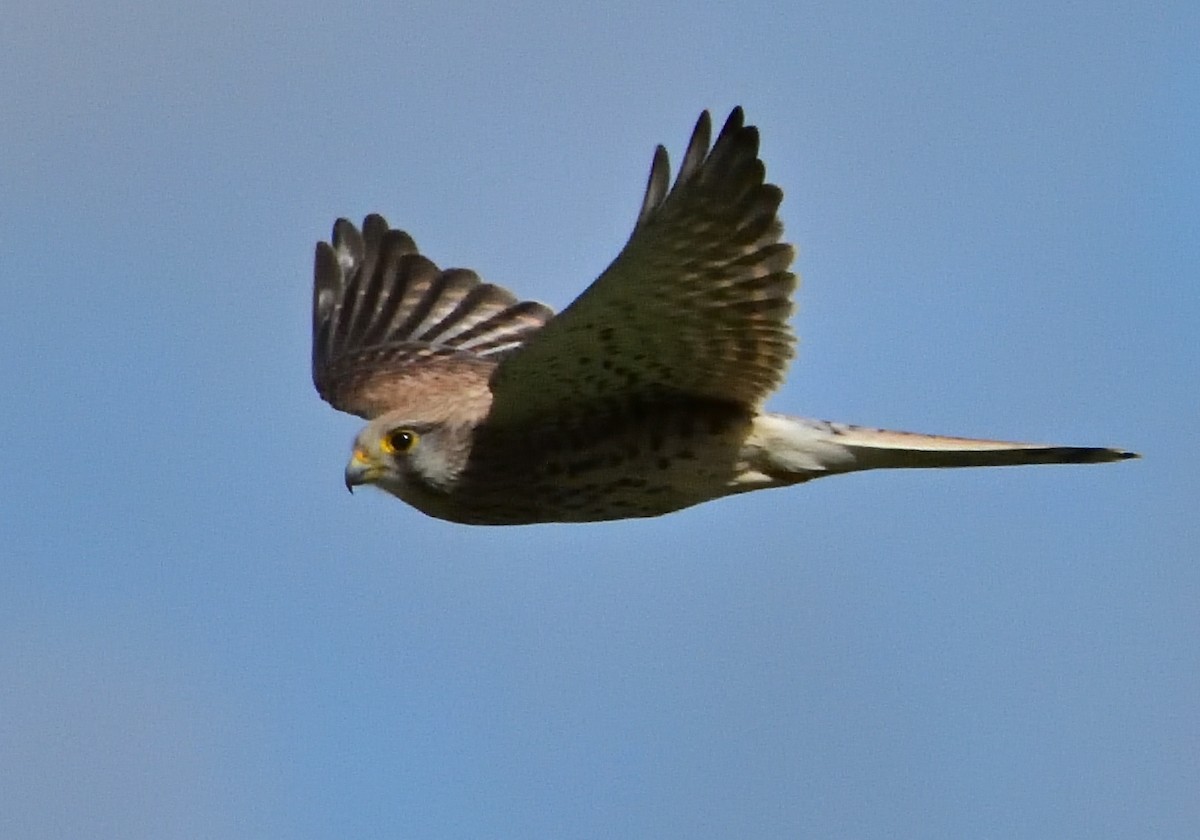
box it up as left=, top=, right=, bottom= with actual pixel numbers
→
left=312, top=108, right=1136, bottom=524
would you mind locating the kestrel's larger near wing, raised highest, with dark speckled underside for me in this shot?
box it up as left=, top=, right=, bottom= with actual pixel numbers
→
left=491, top=108, right=797, bottom=424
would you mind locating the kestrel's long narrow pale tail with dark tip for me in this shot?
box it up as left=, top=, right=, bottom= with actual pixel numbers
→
left=748, top=414, right=1139, bottom=482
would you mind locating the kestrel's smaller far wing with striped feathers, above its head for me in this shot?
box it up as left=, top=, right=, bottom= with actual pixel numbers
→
left=312, top=215, right=553, bottom=419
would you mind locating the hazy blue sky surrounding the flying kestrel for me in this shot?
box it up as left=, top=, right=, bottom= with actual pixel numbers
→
left=0, top=0, right=1200, bottom=840
